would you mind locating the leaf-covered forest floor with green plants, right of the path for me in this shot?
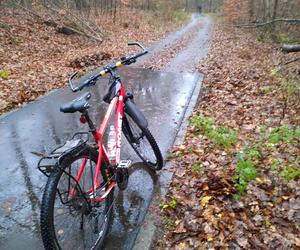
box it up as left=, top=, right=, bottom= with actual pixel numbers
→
left=156, top=24, right=300, bottom=249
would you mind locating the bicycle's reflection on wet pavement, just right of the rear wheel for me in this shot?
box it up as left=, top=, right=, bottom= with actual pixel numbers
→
left=104, top=162, right=158, bottom=249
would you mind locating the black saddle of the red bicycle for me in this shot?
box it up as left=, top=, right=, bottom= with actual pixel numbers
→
left=60, top=92, right=91, bottom=113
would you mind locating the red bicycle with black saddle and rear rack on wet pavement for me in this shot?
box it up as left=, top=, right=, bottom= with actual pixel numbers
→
left=38, top=42, right=163, bottom=249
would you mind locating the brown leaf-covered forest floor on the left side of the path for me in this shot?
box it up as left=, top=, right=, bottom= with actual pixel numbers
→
left=0, top=6, right=190, bottom=114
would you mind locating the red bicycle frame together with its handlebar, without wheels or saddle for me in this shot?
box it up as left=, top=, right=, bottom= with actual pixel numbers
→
left=69, top=42, right=148, bottom=202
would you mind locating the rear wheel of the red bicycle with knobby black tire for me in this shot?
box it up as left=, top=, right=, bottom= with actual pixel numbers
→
left=41, top=146, right=113, bottom=249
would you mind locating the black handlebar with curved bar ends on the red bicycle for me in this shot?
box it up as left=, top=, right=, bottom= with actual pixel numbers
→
left=68, top=42, right=148, bottom=92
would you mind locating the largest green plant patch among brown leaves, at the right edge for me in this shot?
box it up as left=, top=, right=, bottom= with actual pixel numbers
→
left=233, top=124, right=300, bottom=197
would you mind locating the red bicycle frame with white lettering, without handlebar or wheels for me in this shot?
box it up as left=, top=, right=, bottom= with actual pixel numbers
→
left=70, top=80, right=125, bottom=202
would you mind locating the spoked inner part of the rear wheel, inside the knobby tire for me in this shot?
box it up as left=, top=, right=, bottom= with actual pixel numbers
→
left=53, top=157, right=108, bottom=249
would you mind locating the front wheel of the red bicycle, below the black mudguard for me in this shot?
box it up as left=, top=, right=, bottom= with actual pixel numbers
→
left=122, top=115, right=163, bottom=171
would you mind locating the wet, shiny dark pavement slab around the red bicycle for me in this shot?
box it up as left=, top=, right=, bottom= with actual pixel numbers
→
left=0, top=68, right=198, bottom=249
